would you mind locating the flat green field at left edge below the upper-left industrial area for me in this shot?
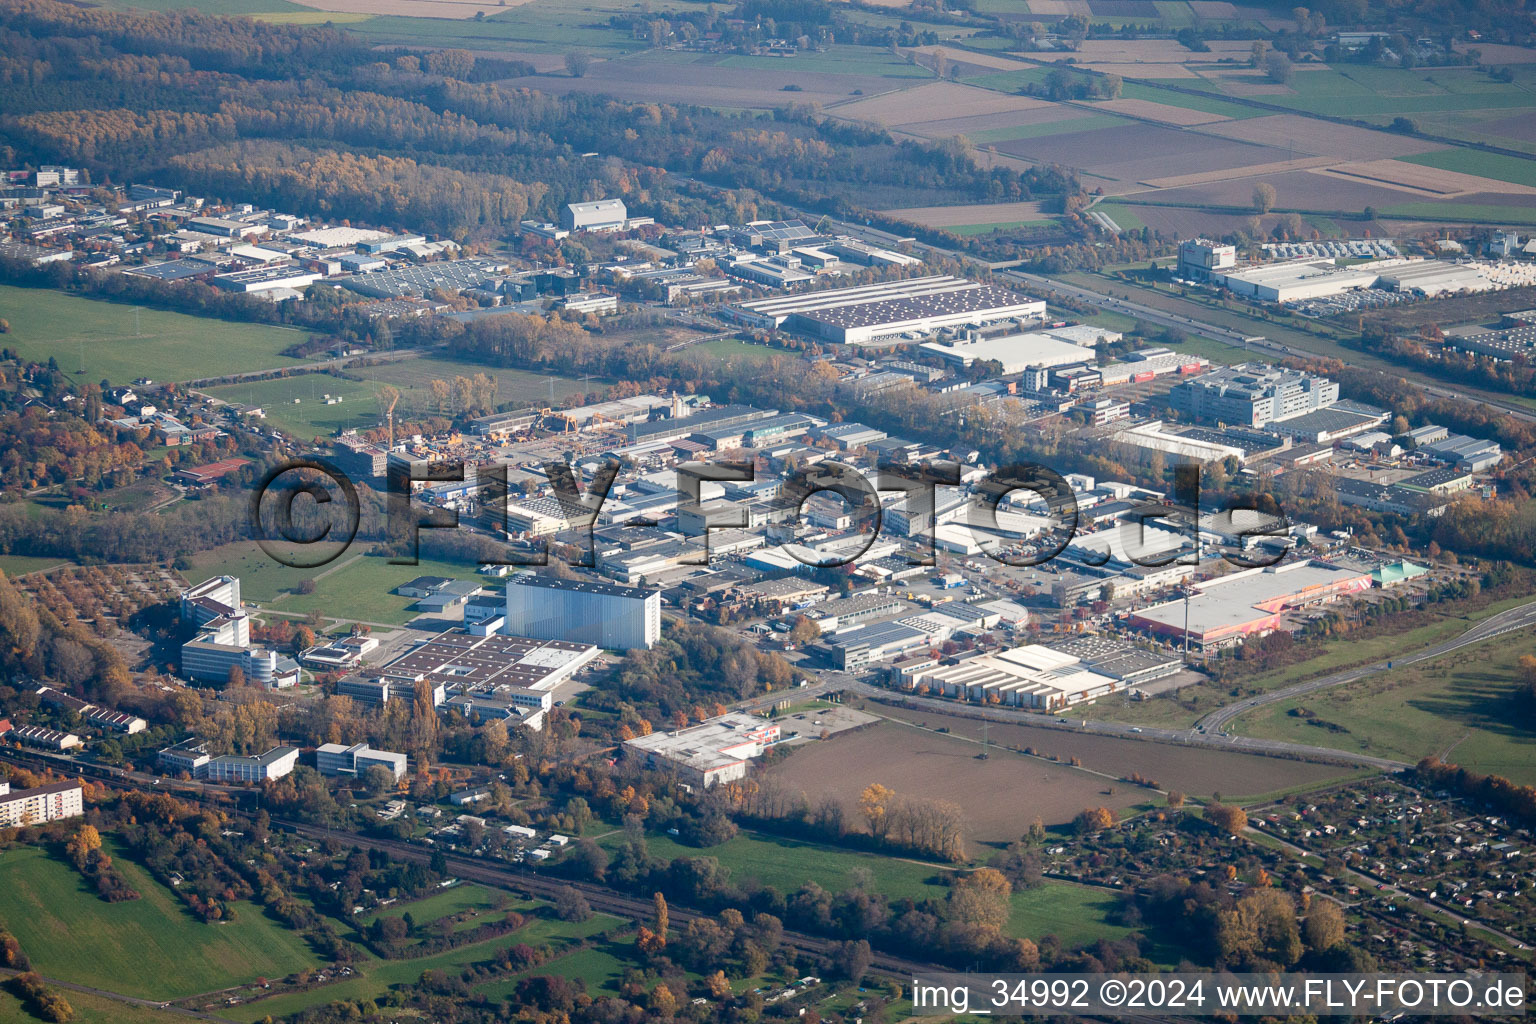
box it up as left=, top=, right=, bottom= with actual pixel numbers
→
left=0, top=284, right=307, bottom=384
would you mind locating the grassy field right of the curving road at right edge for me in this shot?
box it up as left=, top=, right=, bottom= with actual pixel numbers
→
left=1232, top=632, right=1536, bottom=786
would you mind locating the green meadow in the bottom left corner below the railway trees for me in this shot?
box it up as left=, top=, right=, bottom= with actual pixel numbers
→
left=0, top=846, right=315, bottom=999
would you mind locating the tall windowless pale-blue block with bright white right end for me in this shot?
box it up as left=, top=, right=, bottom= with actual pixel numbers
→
left=507, top=573, right=662, bottom=651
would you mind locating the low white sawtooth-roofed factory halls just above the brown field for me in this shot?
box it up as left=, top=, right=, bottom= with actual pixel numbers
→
left=902, top=643, right=1123, bottom=711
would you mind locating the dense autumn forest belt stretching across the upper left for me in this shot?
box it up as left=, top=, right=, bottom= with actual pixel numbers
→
left=0, top=0, right=1077, bottom=241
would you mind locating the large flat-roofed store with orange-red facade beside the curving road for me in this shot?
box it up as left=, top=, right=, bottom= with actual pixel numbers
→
left=1129, top=562, right=1370, bottom=648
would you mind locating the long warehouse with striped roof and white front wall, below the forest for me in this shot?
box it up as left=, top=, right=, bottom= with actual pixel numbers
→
left=728, top=275, right=1046, bottom=345
